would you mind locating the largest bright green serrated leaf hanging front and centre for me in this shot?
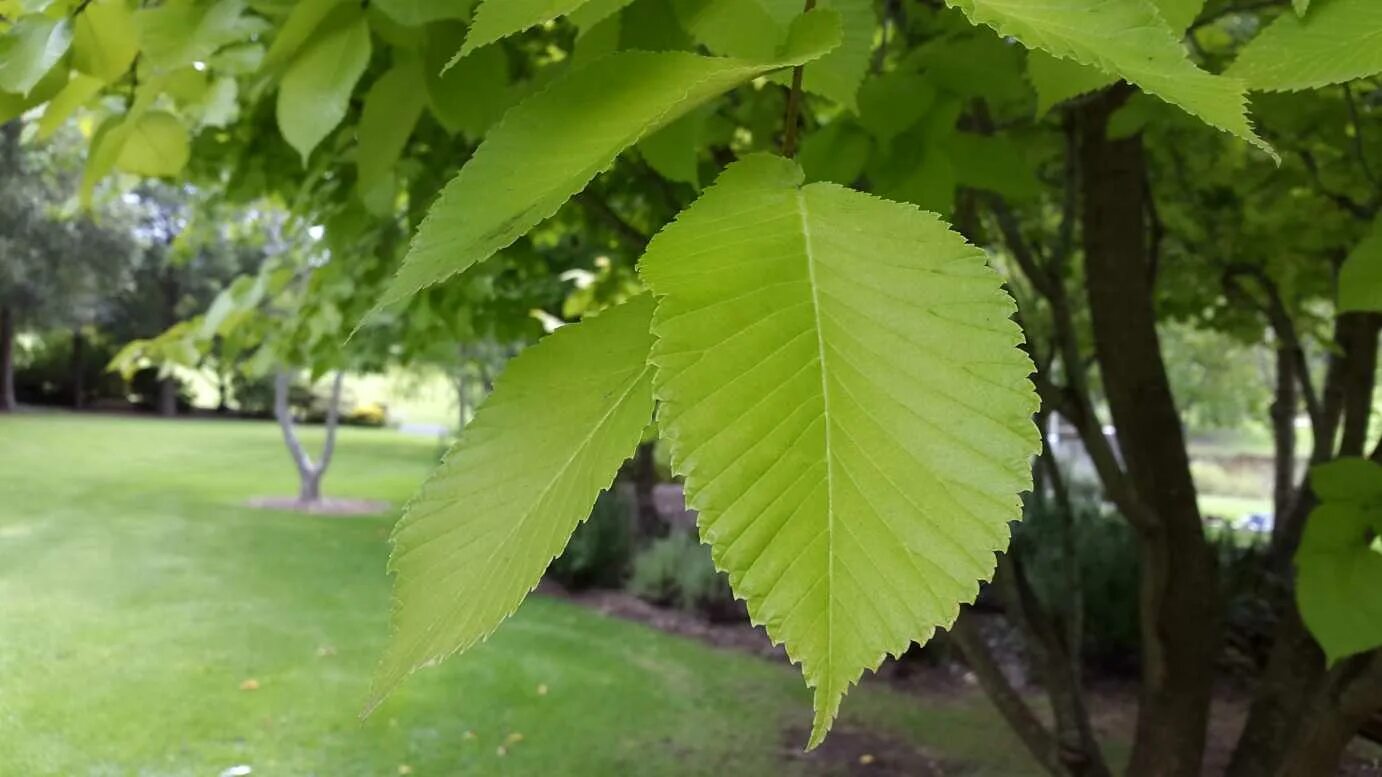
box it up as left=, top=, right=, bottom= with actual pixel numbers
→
left=641, top=155, right=1038, bottom=747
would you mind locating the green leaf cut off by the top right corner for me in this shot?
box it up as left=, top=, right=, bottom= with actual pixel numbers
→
left=1226, top=0, right=1382, bottom=91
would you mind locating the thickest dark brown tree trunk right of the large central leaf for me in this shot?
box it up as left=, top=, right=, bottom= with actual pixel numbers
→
left=1079, top=87, right=1219, bottom=777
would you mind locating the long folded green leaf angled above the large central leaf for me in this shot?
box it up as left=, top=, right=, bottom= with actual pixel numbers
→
left=380, top=11, right=839, bottom=307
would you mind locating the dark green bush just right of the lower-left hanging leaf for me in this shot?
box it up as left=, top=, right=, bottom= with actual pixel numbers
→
left=547, top=491, right=633, bottom=590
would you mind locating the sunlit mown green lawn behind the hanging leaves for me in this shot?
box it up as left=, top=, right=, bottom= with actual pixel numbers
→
left=0, top=415, right=1034, bottom=777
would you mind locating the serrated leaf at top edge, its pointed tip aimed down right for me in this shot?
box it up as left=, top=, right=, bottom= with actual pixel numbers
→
left=947, top=0, right=1276, bottom=156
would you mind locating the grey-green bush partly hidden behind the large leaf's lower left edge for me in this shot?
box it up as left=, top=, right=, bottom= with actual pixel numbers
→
left=629, top=530, right=746, bottom=621
